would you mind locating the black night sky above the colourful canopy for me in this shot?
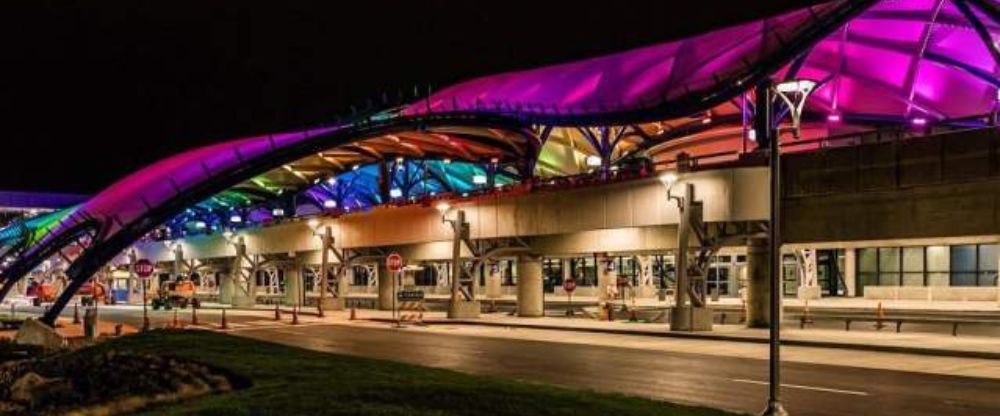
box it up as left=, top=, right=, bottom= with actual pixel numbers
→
left=0, top=0, right=804, bottom=193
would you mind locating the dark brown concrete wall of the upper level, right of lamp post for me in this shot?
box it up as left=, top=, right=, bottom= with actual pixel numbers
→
left=782, top=129, right=1000, bottom=243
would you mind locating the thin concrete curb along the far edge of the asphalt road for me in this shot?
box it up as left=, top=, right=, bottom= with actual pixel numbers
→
left=365, top=318, right=1000, bottom=360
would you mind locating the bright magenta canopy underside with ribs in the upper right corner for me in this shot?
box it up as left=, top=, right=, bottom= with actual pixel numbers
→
left=797, top=0, right=1000, bottom=120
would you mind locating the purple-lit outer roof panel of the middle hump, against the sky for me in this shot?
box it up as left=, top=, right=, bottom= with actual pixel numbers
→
left=405, top=1, right=859, bottom=124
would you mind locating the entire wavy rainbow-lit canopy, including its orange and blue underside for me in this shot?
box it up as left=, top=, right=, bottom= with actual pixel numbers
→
left=3, top=0, right=1000, bottom=324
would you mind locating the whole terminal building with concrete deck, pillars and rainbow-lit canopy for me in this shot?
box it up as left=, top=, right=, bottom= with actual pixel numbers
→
left=0, top=0, right=1000, bottom=323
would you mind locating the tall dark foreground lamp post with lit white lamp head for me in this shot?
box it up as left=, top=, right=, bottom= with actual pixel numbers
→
left=754, top=80, right=817, bottom=416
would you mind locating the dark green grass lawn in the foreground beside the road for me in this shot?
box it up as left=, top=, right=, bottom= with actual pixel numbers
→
left=94, top=331, right=728, bottom=416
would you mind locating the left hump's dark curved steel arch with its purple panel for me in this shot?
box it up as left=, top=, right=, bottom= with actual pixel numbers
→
left=39, top=115, right=536, bottom=325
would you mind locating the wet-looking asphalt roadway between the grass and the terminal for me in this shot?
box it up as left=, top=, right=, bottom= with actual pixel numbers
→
left=19, top=309, right=1000, bottom=416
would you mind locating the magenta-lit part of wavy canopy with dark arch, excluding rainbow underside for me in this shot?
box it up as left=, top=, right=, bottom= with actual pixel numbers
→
left=3, top=0, right=1000, bottom=322
